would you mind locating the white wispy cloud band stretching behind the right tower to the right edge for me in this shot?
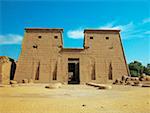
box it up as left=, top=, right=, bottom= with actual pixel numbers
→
left=67, top=18, right=150, bottom=39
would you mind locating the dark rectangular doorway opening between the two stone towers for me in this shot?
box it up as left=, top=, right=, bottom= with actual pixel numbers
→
left=68, top=58, right=80, bottom=84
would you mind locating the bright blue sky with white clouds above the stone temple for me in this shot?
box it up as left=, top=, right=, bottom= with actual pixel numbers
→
left=0, top=0, right=150, bottom=65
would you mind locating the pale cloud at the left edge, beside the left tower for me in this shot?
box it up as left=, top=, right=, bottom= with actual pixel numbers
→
left=0, top=34, right=23, bottom=44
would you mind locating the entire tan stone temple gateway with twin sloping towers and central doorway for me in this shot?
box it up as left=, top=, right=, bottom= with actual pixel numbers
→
left=14, top=28, right=129, bottom=84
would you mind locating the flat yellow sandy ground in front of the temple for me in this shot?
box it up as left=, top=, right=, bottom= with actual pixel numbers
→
left=0, top=84, right=150, bottom=113
